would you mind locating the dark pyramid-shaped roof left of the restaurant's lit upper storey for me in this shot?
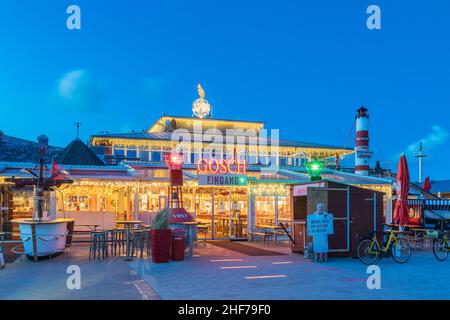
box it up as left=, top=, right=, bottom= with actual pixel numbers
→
left=54, top=138, right=105, bottom=166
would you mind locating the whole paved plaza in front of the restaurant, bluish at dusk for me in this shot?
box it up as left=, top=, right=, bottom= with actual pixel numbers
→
left=0, top=243, right=450, bottom=300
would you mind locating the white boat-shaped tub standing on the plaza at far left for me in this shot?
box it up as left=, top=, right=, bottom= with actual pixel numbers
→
left=11, top=218, right=75, bottom=261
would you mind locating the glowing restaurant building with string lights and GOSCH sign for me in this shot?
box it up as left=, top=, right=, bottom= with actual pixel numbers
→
left=0, top=87, right=392, bottom=239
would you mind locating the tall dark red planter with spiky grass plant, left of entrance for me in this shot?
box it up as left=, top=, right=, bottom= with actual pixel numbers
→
left=151, top=208, right=172, bottom=263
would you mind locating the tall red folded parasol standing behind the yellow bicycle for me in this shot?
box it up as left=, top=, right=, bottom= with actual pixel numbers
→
left=394, top=155, right=409, bottom=226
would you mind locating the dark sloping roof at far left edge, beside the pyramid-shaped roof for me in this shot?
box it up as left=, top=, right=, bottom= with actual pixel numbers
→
left=0, top=134, right=62, bottom=163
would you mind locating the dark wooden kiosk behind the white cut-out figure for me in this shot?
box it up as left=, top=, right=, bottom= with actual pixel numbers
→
left=291, top=181, right=385, bottom=256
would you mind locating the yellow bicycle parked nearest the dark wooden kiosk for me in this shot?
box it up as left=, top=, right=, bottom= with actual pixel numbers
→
left=357, top=229, right=411, bottom=265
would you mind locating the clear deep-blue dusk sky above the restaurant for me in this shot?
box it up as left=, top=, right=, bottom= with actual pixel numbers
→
left=0, top=0, right=450, bottom=179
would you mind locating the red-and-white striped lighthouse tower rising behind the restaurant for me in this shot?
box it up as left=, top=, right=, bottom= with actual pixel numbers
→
left=355, top=107, right=372, bottom=176
